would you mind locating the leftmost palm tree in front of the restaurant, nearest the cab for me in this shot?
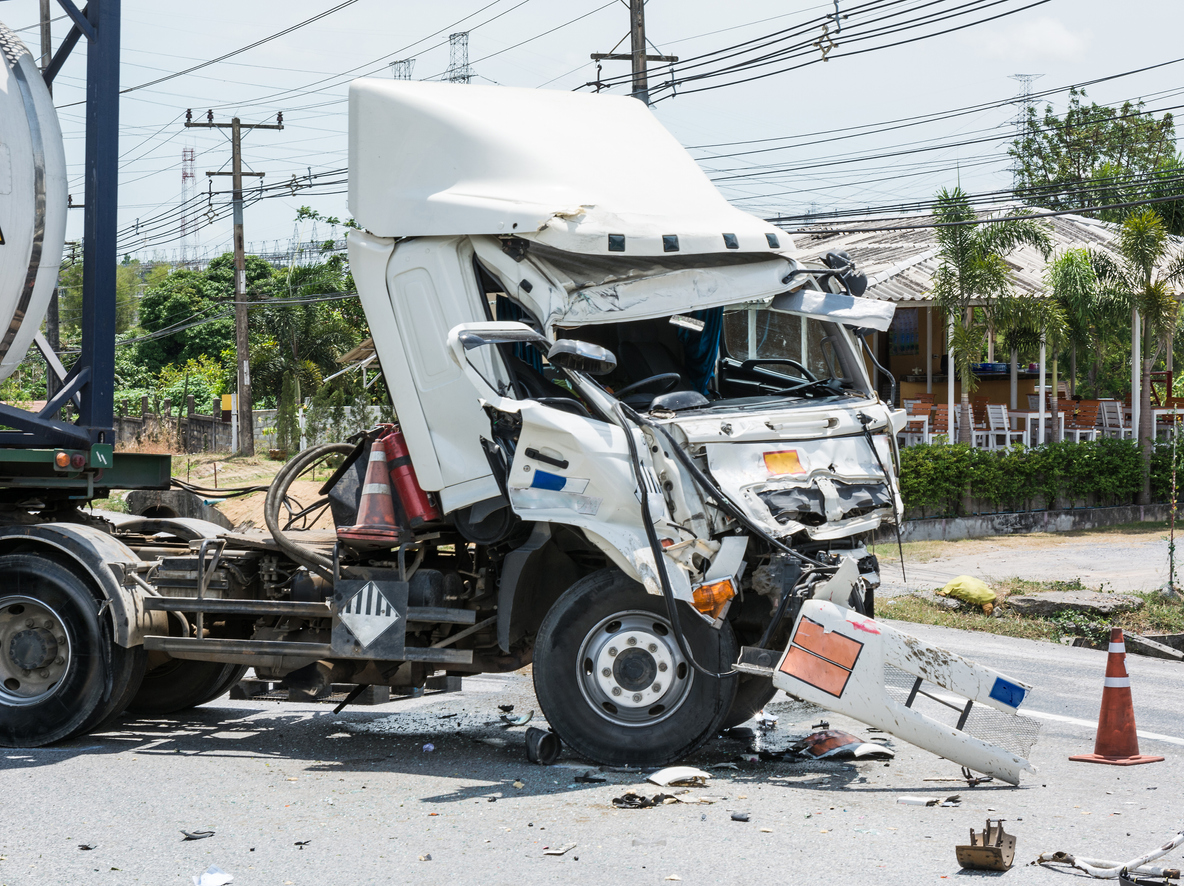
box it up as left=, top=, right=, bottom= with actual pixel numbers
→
left=932, top=187, right=1051, bottom=443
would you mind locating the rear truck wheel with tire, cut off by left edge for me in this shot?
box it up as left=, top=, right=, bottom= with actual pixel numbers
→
left=0, top=553, right=130, bottom=747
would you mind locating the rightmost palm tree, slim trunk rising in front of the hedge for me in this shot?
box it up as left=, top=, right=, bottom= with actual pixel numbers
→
left=1090, top=208, right=1184, bottom=505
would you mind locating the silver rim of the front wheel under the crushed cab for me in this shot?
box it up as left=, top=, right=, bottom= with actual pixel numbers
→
left=575, top=610, right=694, bottom=726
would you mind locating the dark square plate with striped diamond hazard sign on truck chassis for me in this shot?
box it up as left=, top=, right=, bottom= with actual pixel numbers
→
left=333, top=580, right=408, bottom=661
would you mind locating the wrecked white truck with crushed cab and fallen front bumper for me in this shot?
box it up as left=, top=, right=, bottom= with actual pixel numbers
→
left=0, top=34, right=1029, bottom=783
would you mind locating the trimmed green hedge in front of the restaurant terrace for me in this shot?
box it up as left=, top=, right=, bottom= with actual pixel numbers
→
left=900, top=437, right=1184, bottom=518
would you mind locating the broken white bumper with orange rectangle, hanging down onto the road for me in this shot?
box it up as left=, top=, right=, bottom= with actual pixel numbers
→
left=767, top=599, right=1036, bottom=784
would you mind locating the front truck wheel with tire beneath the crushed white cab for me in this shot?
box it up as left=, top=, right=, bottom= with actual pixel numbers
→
left=534, top=570, right=738, bottom=766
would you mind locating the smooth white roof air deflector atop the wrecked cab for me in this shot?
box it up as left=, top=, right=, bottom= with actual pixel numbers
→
left=349, top=79, right=792, bottom=257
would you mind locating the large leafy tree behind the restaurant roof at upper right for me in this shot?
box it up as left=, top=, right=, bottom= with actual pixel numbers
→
left=1008, top=90, right=1184, bottom=232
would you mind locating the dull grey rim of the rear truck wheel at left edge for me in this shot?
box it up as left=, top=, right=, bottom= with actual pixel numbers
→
left=0, top=596, right=72, bottom=706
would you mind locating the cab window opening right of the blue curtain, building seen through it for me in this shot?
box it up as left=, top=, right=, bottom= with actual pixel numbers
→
left=721, top=307, right=856, bottom=397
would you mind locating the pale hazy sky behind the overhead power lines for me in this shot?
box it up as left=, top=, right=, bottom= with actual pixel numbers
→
left=0, top=0, right=1184, bottom=259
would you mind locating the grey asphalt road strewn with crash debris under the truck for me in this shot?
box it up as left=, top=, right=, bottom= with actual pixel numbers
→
left=0, top=625, right=1184, bottom=886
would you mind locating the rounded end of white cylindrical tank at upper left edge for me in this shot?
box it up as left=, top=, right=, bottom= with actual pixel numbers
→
left=0, top=24, right=66, bottom=380
